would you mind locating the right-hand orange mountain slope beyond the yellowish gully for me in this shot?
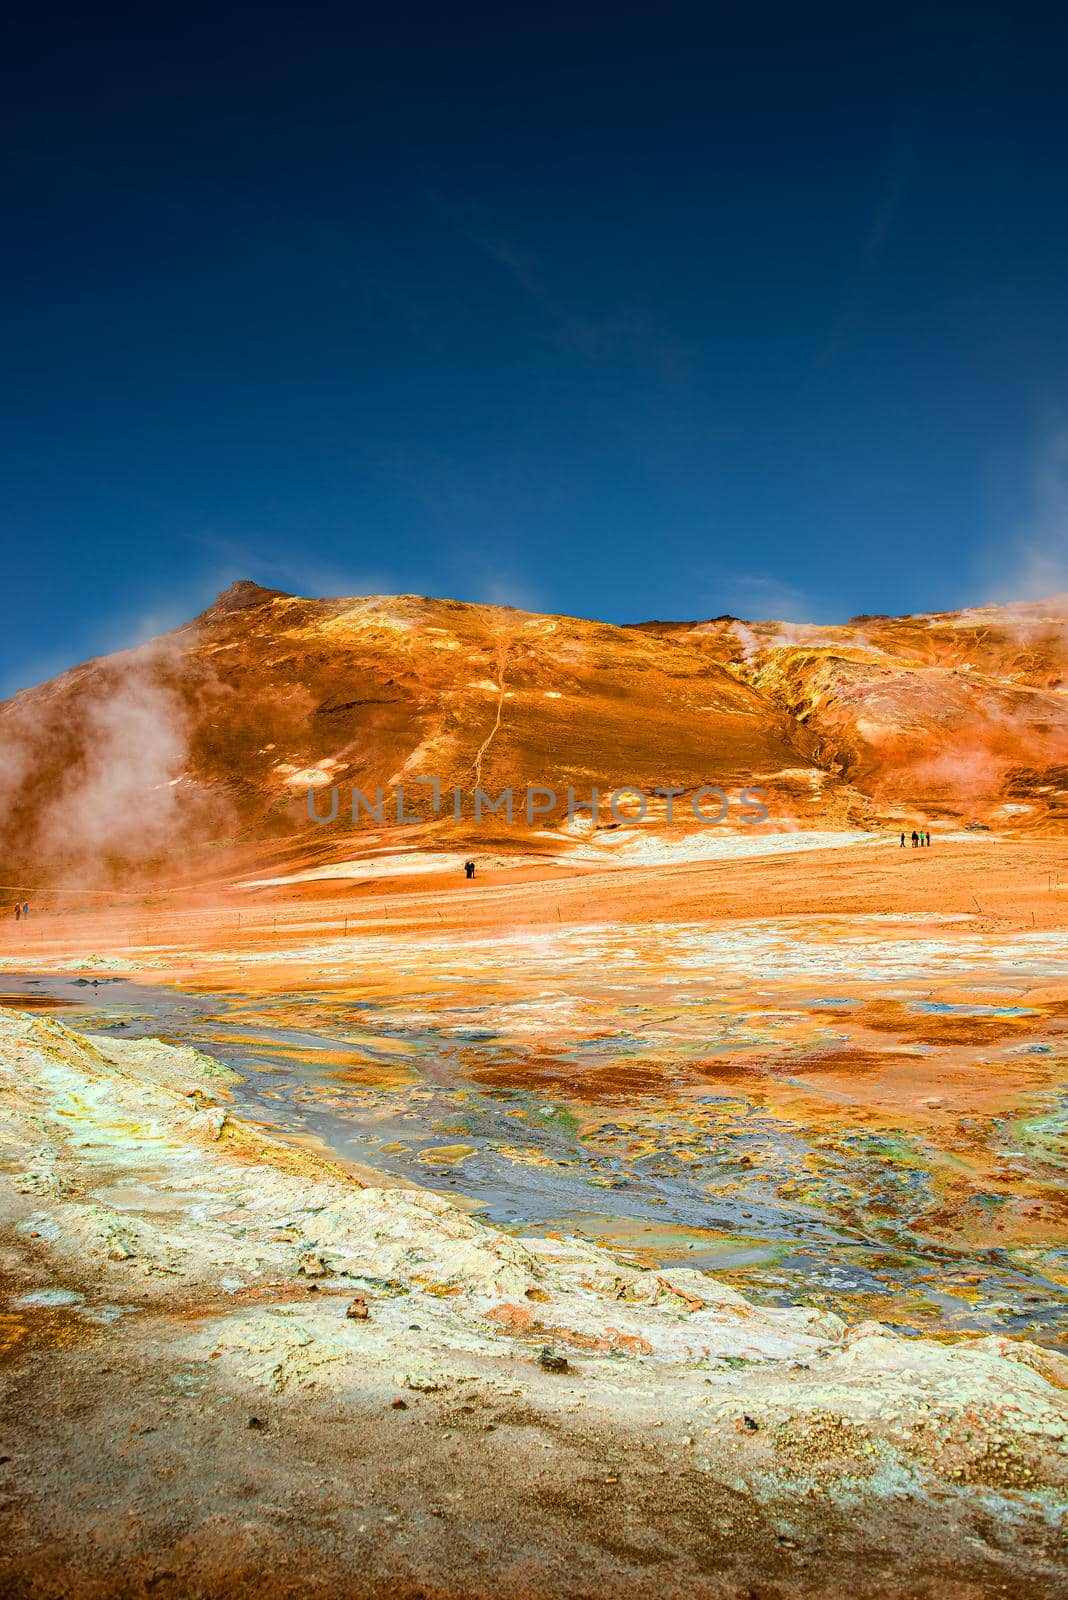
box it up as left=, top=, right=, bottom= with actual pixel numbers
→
left=633, top=595, right=1068, bottom=829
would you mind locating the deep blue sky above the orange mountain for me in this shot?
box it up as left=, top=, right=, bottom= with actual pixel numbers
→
left=0, top=0, right=1068, bottom=691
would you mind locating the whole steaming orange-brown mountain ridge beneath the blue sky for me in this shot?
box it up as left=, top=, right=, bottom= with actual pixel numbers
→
left=0, top=582, right=1068, bottom=883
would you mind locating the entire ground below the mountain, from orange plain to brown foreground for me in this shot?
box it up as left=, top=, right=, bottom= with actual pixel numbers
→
left=0, top=835, right=1068, bottom=1600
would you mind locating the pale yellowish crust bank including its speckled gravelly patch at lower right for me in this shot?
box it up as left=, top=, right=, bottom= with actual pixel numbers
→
left=0, top=1011, right=1068, bottom=1592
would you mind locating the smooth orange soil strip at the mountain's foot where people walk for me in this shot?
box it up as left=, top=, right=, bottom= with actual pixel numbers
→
left=0, top=837, right=1068, bottom=972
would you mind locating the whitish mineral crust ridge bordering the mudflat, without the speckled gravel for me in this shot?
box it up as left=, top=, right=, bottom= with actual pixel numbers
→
left=0, top=1011, right=1068, bottom=1483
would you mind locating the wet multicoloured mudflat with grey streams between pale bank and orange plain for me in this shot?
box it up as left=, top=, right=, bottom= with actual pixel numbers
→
left=0, top=918, right=1068, bottom=1344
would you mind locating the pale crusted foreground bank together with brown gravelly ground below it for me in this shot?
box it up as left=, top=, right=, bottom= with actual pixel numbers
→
left=0, top=1013, right=1068, bottom=1597
